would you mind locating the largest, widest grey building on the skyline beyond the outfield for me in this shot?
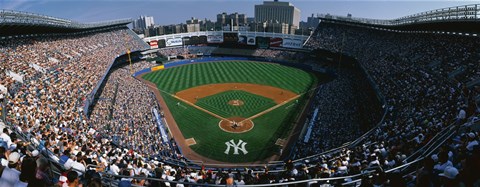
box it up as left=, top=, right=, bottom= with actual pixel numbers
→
left=255, top=0, right=300, bottom=28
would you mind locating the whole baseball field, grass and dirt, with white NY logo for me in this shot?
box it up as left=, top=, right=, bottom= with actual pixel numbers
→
left=142, top=61, right=318, bottom=163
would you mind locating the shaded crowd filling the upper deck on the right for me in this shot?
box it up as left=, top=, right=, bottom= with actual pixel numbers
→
left=300, top=23, right=480, bottom=185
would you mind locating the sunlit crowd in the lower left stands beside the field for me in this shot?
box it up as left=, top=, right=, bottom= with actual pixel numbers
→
left=90, top=61, right=179, bottom=158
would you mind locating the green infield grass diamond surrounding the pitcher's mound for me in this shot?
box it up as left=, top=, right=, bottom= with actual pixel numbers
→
left=195, top=90, right=275, bottom=118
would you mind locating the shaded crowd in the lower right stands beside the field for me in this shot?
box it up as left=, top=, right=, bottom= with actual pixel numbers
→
left=293, top=68, right=382, bottom=159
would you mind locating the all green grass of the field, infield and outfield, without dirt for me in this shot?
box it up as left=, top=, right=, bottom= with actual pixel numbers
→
left=143, top=61, right=317, bottom=163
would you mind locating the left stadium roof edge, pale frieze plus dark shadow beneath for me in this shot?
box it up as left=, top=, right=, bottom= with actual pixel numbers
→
left=0, top=10, right=132, bottom=36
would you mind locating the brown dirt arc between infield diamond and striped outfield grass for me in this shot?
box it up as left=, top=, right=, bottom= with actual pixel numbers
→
left=175, top=83, right=298, bottom=104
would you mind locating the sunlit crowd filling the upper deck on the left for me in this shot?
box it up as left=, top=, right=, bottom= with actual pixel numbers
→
left=0, top=29, right=149, bottom=186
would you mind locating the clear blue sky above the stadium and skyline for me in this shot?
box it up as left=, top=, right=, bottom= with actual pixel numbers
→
left=0, top=0, right=480, bottom=25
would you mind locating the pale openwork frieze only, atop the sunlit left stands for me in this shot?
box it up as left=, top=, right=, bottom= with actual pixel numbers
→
left=0, top=10, right=132, bottom=29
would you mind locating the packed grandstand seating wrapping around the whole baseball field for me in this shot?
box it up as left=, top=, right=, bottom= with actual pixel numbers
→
left=0, top=5, right=480, bottom=186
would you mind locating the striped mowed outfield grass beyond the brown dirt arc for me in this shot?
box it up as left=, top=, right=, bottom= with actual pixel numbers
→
left=143, top=61, right=313, bottom=94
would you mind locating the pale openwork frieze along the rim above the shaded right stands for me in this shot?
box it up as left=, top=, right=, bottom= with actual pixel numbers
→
left=319, top=4, right=480, bottom=26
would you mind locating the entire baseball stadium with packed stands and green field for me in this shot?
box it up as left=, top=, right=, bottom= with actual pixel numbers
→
left=0, top=0, right=480, bottom=187
